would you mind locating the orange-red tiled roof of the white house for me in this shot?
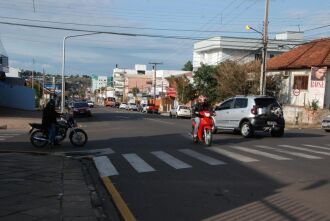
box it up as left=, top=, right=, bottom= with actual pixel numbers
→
left=267, top=38, right=330, bottom=70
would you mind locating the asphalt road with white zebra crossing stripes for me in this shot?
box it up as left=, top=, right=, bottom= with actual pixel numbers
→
left=0, top=108, right=330, bottom=221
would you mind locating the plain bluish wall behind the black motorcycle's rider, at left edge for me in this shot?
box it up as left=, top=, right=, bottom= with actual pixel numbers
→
left=0, top=82, right=35, bottom=110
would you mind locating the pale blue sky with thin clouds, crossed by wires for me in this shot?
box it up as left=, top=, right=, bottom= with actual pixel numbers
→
left=0, top=0, right=330, bottom=75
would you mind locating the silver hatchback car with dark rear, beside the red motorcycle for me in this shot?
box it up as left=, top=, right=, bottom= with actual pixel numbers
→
left=213, top=96, right=285, bottom=137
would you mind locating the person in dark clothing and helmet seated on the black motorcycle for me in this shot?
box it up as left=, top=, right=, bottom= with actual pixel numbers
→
left=42, top=99, right=61, bottom=145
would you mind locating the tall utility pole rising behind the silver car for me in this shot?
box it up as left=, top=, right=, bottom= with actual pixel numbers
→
left=260, top=0, right=269, bottom=95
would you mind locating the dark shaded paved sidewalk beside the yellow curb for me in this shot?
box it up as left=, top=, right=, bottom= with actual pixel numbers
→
left=0, top=153, right=107, bottom=221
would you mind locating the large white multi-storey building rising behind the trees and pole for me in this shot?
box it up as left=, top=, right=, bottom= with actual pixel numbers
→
left=193, top=31, right=303, bottom=70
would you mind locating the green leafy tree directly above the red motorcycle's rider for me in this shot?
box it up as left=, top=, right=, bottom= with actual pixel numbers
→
left=194, top=64, right=220, bottom=104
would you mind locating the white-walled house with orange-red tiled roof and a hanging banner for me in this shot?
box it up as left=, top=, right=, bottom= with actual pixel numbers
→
left=267, top=38, right=330, bottom=108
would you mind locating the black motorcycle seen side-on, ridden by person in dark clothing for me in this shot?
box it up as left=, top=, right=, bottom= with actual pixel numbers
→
left=29, top=116, right=88, bottom=148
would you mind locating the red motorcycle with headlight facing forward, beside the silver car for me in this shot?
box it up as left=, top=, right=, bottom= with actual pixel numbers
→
left=192, top=111, right=214, bottom=146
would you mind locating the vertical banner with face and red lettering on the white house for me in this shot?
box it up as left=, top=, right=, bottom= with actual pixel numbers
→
left=309, top=67, right=327, bottom=107
